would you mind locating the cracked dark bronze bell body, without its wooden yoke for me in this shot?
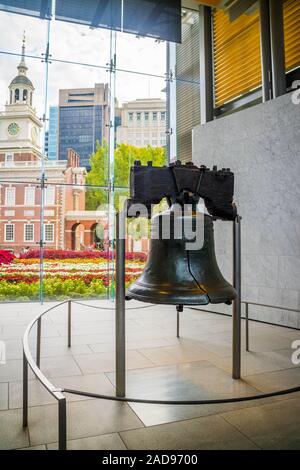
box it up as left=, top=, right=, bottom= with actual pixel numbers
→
left=126, top=207, right=236, bottom=305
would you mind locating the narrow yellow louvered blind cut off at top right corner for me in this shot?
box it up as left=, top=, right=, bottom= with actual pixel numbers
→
left=283, top=0, right=300, bottom=72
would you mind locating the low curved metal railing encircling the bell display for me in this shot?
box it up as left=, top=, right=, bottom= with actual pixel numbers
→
left=23, top=299, right=300, bottom=450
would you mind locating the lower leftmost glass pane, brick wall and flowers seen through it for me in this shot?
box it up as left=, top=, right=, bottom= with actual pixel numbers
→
left=0, top=180, right=41, bottom=302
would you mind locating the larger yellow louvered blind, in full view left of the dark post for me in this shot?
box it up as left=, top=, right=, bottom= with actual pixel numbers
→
left=213, top=10, right=261, bottom=107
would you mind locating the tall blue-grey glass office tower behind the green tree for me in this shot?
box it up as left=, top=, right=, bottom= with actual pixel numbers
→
left=58, top=83, right=109, bottom=169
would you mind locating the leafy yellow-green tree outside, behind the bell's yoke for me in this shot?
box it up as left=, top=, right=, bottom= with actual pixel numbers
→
left=86, top=143, right=166, bottom=210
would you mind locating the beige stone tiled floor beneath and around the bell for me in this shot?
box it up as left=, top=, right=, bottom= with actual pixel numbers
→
left=0, top=301, right=300, bottom=450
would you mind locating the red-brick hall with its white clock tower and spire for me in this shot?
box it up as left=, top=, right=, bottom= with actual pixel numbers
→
left=0, top=40, right=108, bottom=254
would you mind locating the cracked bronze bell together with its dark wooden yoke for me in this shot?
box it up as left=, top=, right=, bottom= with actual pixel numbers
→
left=126, top=163, right=236, bottom=305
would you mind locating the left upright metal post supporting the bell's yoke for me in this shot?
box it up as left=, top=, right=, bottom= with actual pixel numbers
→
left=115, top=211, right=126, bottom=397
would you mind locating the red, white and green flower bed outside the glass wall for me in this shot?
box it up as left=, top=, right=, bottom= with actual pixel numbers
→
left=0, top=250, right=145, bottom=301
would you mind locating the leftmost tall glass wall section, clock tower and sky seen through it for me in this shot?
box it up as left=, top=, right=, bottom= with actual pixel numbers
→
left=0, top=9, right=49, bottom=301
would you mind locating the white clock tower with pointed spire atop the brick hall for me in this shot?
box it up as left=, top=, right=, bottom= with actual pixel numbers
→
left=0, top=35, right=43, bottom=161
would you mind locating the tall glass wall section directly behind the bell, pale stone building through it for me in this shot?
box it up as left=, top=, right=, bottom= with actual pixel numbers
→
left=114, top=40, right=167, bottom=285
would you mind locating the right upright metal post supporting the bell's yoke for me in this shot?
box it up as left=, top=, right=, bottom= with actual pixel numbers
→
left=232, top=215, right=241, bottom=379
